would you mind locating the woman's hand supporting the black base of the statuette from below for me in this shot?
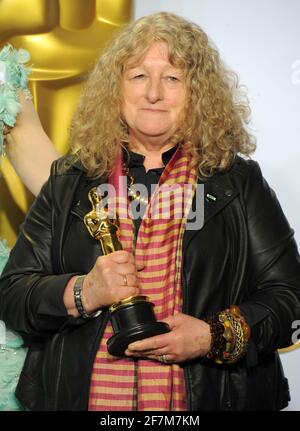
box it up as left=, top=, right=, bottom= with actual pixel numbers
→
left=125, top=313, right=211, bottom=363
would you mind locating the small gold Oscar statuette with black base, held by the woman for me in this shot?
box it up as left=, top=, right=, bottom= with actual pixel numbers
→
left=84, top=187, right=170, bottom=356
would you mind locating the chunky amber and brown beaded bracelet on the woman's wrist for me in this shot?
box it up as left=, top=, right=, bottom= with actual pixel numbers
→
left=204, top=305, right=251, bottom=364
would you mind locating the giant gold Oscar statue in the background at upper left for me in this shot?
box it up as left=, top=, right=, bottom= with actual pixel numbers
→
left=0, top=0, right=132, bottom=245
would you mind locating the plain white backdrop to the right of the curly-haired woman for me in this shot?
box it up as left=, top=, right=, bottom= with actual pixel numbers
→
left=135, top=0, right=300, bottom=410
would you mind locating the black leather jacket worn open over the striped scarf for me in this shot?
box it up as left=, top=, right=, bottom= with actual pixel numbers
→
left=0, top=157, right=300, bottom=410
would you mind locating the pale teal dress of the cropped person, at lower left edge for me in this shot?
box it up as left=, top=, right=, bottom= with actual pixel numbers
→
left=0, top=241, right=26, bottom=411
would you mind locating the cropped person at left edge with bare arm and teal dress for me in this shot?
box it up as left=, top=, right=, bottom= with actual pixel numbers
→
left=0, top=92, right=58, bottom=411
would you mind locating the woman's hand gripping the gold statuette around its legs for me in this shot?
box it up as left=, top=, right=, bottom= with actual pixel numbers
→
left=82, top=250, right=141, bottom=313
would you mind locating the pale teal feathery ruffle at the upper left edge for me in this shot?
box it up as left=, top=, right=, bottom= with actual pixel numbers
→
left=0, top=44, right=31, bottom=156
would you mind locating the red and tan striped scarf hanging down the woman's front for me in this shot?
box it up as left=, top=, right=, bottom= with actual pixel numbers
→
left=89, top=146, right=197, bottom=411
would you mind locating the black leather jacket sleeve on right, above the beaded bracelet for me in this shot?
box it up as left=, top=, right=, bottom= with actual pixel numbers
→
left=240, top=161, right=300, bottom=355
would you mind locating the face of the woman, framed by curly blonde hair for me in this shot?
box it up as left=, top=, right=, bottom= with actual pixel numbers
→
left=122, top=42, right=186, bottom=148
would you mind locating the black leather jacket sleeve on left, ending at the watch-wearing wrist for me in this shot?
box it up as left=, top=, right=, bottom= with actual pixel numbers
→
left=0, top=162, right=82, bottom=336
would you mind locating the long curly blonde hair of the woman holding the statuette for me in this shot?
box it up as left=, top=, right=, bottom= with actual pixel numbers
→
left=71, top=12, right=256, bottom=178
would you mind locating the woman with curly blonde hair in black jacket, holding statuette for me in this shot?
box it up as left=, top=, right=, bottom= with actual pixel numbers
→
left=0, top=13, right=300, bottom=411
